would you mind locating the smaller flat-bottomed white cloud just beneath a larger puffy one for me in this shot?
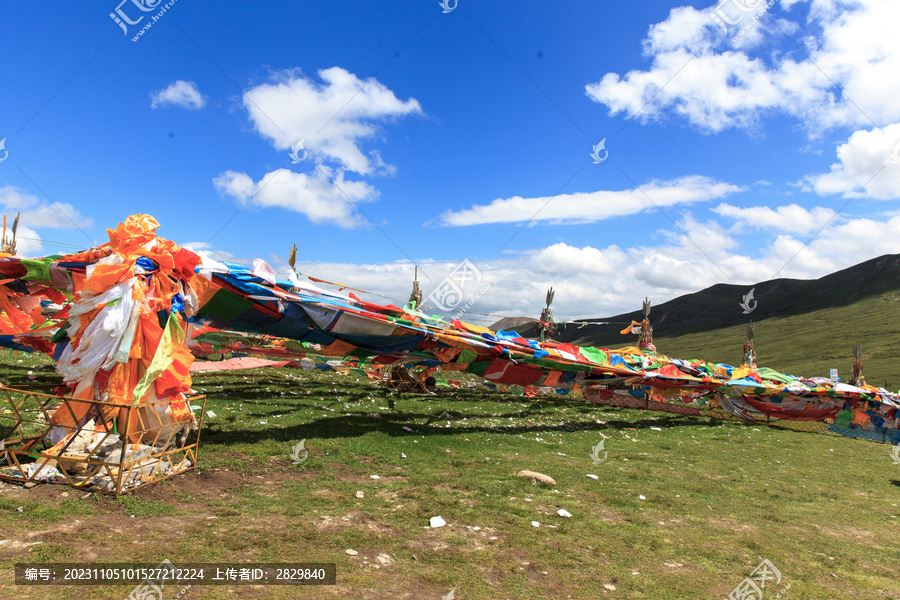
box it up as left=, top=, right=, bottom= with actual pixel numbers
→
left=213, top=166, right=378, bottom=228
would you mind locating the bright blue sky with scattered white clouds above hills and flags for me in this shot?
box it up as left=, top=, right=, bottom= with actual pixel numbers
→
left=0, top=0, right=900, bottom=322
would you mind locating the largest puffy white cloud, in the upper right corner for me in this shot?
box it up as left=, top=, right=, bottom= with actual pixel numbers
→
left=585, top=0, right=900, bottom=135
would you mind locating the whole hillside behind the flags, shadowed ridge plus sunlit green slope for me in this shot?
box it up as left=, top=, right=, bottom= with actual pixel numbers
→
left=497, top=255, right=900, bottom=388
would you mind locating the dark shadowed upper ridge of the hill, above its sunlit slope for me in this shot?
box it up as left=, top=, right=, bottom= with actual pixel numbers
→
left=491, top=254, right=900, bottom=351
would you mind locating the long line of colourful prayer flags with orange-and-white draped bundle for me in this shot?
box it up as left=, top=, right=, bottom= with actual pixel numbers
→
left=0, top=215, right=900, bottom=444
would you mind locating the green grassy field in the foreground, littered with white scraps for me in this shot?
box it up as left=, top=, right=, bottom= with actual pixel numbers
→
left=0, top=354, right=900, bottom=600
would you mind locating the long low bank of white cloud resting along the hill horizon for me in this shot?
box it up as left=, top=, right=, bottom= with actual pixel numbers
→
left=243, top=206, right=900, bottom=324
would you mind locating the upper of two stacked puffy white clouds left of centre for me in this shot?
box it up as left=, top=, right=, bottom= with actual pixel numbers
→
left=244, top=67, right=422, bottom=175
